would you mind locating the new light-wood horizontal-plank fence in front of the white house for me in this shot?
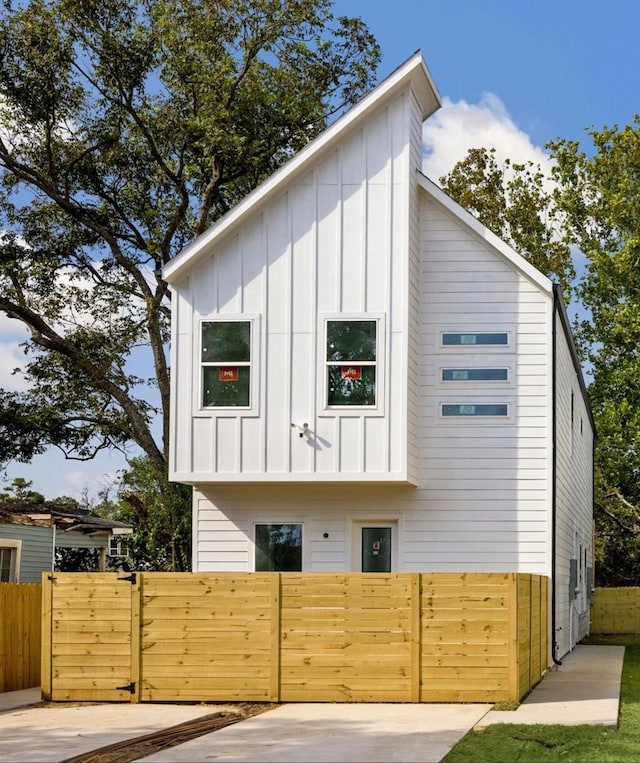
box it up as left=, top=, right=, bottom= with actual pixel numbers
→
left=41, top=572, right=548, bottom=702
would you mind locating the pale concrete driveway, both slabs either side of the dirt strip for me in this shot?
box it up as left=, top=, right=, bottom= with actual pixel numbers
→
left=0, top=703, right=491, bottom=763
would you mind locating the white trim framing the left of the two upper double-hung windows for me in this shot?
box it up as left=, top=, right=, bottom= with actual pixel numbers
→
left=198, top=313, right=262, bottom=418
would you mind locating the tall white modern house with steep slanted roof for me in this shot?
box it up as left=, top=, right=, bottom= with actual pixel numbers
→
left=164, top=53, right=594, bottom=657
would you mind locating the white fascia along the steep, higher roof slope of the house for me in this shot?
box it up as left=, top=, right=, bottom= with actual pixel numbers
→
left=163, top=51, right=442, bottom=283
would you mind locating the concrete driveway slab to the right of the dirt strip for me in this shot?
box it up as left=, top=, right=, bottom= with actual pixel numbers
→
left=141, top=703, right=491, bottom=763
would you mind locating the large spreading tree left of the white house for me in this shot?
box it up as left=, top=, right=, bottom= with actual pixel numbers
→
left=0, top=0, right=380, bottom=569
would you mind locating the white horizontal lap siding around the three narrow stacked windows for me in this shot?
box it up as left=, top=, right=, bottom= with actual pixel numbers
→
left=418, top=197, right=552, bottom=574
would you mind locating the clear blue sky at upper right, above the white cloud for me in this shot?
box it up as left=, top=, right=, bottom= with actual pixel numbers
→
left=334, top=0, right=640, bottom=146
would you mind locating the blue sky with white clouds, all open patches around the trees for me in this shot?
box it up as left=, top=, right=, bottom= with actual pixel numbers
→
left=0, top=0, right=640, bottom=498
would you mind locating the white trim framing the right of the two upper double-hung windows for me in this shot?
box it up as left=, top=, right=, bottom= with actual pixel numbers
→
left=317, top=313, right=387, bottom=418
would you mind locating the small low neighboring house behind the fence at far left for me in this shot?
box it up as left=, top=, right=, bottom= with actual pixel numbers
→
left=0, top=503, right=133, bottom=583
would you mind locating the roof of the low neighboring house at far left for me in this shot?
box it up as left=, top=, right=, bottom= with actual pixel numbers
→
left=0, top=502, right=133, bottom=535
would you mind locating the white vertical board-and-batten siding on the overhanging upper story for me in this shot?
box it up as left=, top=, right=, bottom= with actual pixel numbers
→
left=170, top=89, right=420, bottom=484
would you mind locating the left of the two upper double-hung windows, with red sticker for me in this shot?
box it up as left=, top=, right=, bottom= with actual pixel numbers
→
left=200, top=320, right=251, bottom=408
